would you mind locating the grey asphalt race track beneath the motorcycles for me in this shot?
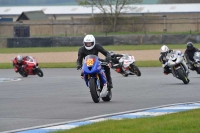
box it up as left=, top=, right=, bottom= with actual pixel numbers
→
left=0, top=68, right=200, bottom=132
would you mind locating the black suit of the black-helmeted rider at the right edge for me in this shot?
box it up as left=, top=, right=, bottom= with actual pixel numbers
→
left=184, top=47, right=200, bottom=70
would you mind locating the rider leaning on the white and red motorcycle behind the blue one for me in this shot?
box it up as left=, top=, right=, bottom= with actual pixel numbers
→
left=109, top=51, right=128, bottom=76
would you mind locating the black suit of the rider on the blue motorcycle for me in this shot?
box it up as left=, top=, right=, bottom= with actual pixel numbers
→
left=77, top=43, right=113, bottom=88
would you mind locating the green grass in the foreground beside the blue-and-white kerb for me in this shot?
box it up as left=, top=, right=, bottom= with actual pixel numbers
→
left=50, top=109, right=200, bottom=133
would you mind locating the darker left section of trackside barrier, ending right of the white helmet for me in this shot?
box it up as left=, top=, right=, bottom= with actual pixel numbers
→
left=7, top=37, right=114, bottom=48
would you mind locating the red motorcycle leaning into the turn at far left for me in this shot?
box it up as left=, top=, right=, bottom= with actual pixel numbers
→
left=12, top=56, right=43, bottom=77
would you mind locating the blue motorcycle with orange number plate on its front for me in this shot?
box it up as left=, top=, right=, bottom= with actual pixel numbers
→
left=82, top=55, right=112, bottom=103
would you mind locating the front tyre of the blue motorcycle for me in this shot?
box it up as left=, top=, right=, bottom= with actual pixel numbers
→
left=89, top=78, right=100, bottom=103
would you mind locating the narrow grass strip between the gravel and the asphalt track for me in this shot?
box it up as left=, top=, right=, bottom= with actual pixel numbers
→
left=0, top=60, right=161, bottom=69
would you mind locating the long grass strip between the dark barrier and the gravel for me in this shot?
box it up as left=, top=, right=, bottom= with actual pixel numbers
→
left=0, top=44, right=200, bottom=54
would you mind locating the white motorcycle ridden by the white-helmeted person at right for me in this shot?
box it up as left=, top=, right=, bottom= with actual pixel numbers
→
left=167, top=50, right=190, bottom=84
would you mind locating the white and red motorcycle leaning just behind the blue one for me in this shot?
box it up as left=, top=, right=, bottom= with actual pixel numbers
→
left=112, top=54, right=141, bottom=77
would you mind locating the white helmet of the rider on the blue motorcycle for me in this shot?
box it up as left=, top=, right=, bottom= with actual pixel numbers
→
left=83, top=35, right=95, bottom=50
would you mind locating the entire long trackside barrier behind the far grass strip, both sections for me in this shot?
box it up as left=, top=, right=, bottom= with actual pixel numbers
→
left=7, top=35, right=200, bottom=48
